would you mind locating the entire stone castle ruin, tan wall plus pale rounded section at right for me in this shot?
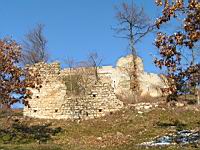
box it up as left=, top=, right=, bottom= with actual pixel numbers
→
left=23, top=55, right=165, bottom=120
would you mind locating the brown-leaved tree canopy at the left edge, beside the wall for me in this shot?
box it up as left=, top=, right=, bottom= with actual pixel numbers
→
left=0, top=39, right=40, bottom=108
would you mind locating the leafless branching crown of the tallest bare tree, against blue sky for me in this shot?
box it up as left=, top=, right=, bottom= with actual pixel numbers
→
left=113, top=3, right=155, bottom=51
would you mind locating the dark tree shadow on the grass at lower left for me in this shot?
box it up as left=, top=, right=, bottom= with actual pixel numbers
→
left=0, top=123, right=61, bottom=144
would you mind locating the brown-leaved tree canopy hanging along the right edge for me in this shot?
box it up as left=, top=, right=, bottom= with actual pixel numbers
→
left=155, top=0, right=200, bottom=99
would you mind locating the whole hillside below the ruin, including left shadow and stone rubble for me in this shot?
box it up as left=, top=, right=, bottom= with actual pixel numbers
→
left=0, top=100, right=200, bottom=150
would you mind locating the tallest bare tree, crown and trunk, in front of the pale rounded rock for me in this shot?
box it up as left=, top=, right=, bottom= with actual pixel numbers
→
left=114, top=2, right=154, bottom=100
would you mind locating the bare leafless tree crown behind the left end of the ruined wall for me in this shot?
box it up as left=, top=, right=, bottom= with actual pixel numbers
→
left=21, top=24, right=48, bottom=65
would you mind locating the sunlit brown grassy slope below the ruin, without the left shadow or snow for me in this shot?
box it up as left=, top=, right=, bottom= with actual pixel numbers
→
left=0, top=101, right=200, bottom=150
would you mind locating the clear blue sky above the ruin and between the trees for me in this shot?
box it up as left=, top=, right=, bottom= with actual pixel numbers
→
left=0, top=0, right=160, bottom=72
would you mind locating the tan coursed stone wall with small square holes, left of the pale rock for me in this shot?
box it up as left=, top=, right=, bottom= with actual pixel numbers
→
left=24, top=63, right=123, bottom=120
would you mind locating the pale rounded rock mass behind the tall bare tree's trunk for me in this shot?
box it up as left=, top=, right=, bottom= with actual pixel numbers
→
left=104, top=55, right=167, bottom=97
